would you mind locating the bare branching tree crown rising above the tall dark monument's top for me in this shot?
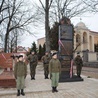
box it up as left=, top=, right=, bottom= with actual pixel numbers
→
left=50, top=0, right=88, bottom=22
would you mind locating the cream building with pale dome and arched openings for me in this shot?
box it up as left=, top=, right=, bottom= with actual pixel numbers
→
left=74, top=22, right=98, bottom=61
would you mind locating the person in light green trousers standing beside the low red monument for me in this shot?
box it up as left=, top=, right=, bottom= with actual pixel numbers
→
left=14, top=55, right=27, bottom=96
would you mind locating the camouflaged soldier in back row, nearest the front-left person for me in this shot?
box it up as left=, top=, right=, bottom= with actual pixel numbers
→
left=28, top=51, right=38, bottom=80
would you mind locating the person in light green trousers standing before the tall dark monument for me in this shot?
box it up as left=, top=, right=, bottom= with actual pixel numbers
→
left=49, top=53, right=61, bottom=93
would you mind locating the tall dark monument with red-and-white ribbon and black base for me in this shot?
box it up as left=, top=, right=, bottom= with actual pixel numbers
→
left=58, top=17, right=83, bottom=82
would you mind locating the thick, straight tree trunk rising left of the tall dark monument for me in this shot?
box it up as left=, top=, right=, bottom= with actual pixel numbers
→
left=45, top=0, right=50, bottom=51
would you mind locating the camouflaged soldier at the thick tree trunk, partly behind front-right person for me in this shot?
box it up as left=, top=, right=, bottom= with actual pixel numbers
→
left=41, top=51, right=51, bottom=79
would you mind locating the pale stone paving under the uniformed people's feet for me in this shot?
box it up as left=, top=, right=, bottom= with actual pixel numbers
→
left=0, top=65, right=98, bottom=98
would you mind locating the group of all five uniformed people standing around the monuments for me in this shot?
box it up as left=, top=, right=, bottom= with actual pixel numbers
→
left=14, top=51, right=83, bottom=96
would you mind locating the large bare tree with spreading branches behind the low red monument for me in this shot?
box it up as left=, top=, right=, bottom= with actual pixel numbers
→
left=1, top=0, right=36, bottom=52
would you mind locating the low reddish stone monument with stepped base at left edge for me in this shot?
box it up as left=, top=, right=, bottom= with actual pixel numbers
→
left=0, top=53, right=16, bottom=88
